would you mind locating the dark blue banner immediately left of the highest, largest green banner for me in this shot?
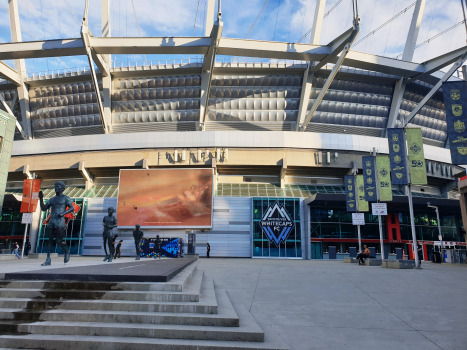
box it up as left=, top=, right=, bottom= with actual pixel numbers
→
left=388, top=128, right=408, bottom=185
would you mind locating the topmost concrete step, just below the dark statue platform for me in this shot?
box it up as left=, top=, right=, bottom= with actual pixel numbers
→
left=0, top=262, right=198, bottom=292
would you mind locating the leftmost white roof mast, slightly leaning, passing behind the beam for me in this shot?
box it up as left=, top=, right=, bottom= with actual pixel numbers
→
left=8, top=0, right=32, bottom=138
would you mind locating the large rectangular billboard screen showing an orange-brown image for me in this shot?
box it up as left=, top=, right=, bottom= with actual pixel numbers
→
left=117, top=169, right=213, bottom=228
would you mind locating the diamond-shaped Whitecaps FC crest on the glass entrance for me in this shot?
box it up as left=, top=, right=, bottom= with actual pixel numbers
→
left=259, top=202, right=294, bottom=246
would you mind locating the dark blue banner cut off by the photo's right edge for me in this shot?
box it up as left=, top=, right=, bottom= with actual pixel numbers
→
left=443, top=81, right=467, bottom=165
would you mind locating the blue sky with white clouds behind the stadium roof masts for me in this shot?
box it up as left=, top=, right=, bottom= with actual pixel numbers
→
left=0, top=0, right=466, bottom=74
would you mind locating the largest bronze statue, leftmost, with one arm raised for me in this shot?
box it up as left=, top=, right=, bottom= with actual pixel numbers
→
left=39, top=181, right=74, bottom=266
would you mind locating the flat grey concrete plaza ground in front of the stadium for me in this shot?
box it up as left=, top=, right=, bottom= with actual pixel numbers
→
left=0, top=257, right=467, bottom=350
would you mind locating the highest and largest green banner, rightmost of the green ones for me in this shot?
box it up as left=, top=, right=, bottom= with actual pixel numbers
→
left=405, top=128, right=427, bottom=185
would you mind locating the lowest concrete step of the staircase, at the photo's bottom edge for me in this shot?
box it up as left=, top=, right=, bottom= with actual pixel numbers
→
left=0, top=326, right=290, bottom=350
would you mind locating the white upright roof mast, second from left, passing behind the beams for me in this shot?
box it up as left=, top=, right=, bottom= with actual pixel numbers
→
left=102, top=0, right=112, bottom=133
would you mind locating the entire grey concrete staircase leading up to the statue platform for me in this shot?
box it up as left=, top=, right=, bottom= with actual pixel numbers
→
left=0, top=263, right=288, bottom=350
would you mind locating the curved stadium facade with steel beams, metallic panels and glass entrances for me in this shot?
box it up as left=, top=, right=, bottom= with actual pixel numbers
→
left=0, top=0, right=467, bottom=259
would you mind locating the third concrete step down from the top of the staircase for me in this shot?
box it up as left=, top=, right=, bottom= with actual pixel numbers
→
left=0, top=270, right=218, bottom=314
